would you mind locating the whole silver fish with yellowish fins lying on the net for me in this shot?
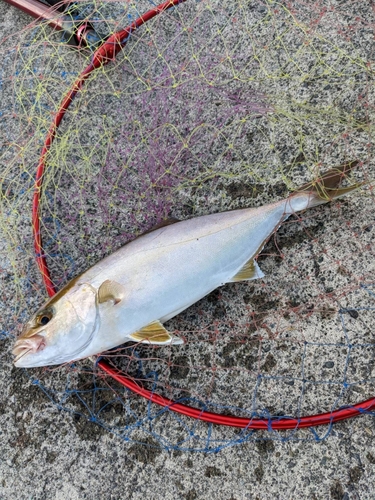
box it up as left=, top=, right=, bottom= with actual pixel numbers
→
left=13, top=161, right=364, bottom=368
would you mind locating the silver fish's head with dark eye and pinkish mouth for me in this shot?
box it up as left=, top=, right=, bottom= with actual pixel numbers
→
left=13, top=280, right=99, bottom=368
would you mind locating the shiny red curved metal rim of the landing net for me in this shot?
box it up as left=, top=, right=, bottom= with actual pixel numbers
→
left=32, top=0, right=375, bottom=431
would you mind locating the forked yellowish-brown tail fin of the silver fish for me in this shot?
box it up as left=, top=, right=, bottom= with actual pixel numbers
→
left=286, top=160, right=366, bottom=213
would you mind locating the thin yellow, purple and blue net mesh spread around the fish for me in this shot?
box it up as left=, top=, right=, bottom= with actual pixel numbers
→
left=0, top=0, right=375, bottom=452
